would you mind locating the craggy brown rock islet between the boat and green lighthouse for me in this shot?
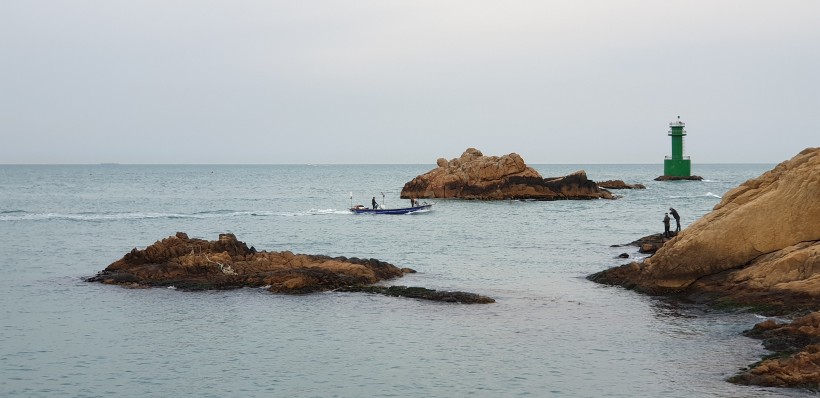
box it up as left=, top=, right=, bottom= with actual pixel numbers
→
left=401, top=148, right=613, bottom=200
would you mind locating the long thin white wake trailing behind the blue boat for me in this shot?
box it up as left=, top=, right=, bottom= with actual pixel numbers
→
left=0, top=209, right=350, bottom=222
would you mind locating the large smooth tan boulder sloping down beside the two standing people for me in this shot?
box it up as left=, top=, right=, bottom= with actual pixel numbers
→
left=598, top=148, right=820, bottom=304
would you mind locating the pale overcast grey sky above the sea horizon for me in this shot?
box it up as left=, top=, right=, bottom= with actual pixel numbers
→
left=0, top=0, right=820, bottom=164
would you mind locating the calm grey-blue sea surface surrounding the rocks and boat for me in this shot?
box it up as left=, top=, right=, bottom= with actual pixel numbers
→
left=0, top=165, right=809, bottom=397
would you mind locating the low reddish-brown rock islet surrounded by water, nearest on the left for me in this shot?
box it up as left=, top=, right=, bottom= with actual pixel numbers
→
left=88, top=232, right=492, bottom=303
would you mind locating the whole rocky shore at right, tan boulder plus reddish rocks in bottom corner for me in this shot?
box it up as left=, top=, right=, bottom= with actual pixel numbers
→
left=589, top=148, right=820, bottom=388
